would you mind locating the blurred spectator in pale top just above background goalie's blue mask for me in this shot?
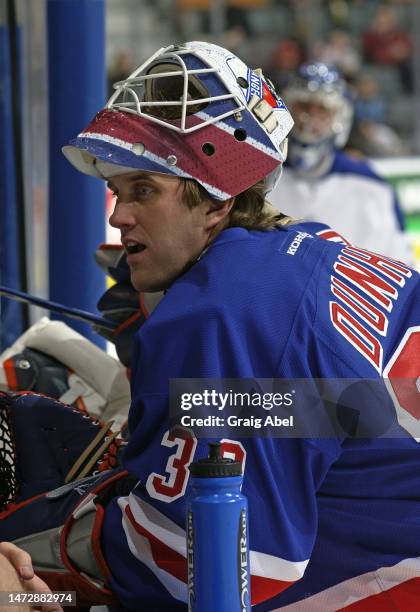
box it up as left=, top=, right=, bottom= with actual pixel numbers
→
left=313, top=30, right=361, bottom=80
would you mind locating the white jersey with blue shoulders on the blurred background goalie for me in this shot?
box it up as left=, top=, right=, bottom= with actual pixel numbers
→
left=267, top=151, right=414, bottom=266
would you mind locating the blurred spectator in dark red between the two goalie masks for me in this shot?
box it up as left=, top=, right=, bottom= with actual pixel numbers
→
left=264, top=38, right=305, bottom=91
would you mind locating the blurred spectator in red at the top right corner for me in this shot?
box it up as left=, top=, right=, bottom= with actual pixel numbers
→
left=363, top=6, right=413, bottom=93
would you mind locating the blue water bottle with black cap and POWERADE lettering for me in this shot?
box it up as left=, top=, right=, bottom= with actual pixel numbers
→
left=186, top=442, right=251, bottom=612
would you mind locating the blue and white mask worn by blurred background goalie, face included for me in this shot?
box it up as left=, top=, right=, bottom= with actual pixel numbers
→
left=283, top=62, right=353, bottom=172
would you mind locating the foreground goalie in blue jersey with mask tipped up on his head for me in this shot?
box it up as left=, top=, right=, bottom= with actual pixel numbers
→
left=0, top=42, right=420, bottom=611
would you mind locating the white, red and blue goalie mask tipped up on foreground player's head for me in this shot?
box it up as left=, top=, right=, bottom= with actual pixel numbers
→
left=63, top=42, right=293, bottom=200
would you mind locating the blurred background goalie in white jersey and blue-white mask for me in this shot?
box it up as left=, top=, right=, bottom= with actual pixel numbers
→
left=269, top=62, right=414, bottom=265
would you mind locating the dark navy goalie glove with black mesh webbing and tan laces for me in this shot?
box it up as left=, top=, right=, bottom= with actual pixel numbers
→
left=0, top=392, right=124, bottom=510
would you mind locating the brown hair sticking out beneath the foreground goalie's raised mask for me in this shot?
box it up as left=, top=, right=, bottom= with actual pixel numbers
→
left=183, top=179, right=294, bottom=230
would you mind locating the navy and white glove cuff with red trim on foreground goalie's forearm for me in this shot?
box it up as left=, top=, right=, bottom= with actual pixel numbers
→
left=0, top=470, right=136, bottom=606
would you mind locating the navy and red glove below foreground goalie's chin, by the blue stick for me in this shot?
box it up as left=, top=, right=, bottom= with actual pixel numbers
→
left=95, top=244, right=164, bottom=368
